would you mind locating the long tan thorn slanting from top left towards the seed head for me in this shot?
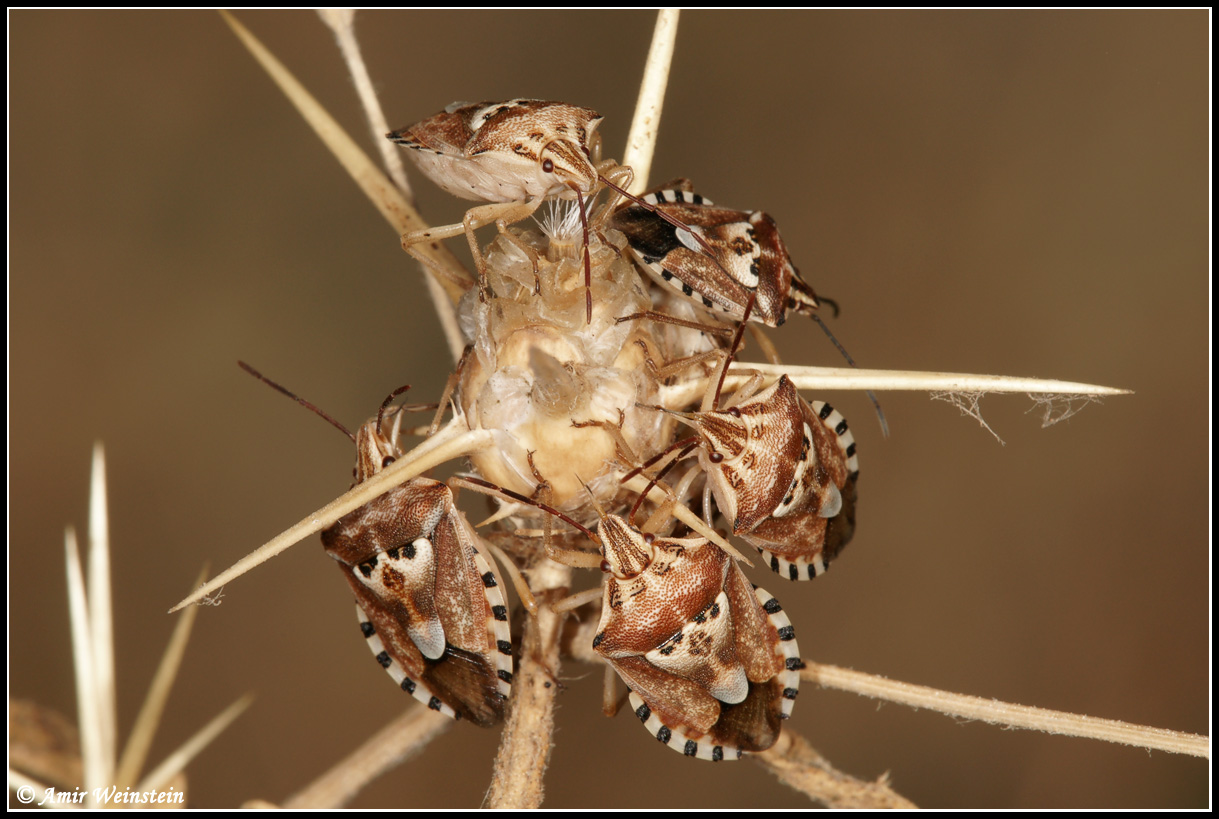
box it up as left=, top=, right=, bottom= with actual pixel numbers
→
left=221, top=11, right=473, bottom=361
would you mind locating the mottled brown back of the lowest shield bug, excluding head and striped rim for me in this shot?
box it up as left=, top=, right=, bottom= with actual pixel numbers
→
left=594, top=539, right=783, bottom=751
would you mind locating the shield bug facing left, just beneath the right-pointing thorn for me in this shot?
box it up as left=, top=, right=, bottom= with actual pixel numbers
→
left=674, top=375, right=859, bottom=580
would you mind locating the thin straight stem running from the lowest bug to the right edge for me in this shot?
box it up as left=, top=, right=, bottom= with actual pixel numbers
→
left=801, top=661, right=1210, bottom=759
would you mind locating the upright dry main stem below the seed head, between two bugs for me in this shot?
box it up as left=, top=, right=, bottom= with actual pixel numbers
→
left=484, top=559, right=572, bottom=809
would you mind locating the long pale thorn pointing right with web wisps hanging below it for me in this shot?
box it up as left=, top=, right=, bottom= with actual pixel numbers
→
left=661, top=362, right=1131, bottom=407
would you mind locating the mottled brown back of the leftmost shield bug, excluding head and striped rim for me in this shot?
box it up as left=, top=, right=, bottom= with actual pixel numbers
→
left=322, top=478, right=505, bottom=725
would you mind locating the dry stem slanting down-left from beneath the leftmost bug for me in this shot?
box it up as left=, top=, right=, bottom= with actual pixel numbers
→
left=283, top=704, right=453, bottom=809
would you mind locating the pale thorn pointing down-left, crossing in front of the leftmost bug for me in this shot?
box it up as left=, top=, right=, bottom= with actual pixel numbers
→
left=169, top=417, right=494, bottom=613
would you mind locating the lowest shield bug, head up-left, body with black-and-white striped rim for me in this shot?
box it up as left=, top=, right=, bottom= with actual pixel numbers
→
left=592, top=514, right=803, bottom=762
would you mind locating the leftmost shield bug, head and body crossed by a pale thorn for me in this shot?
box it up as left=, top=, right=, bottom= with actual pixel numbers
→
left=241, top=363, right=512, bottom=726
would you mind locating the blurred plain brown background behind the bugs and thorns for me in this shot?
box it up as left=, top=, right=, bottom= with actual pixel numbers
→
left=9, top=11, right=1210, bottom=808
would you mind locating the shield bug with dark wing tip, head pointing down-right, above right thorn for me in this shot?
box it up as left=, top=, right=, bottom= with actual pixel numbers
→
left=608, top=179, right=820, bottom=327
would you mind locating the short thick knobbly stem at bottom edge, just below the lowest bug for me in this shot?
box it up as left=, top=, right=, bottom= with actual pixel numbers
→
left=750, top=728, right=918, bottom=809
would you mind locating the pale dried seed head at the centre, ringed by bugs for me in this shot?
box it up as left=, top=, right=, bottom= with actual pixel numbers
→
left=461, top=224, right=662, bottom=519
